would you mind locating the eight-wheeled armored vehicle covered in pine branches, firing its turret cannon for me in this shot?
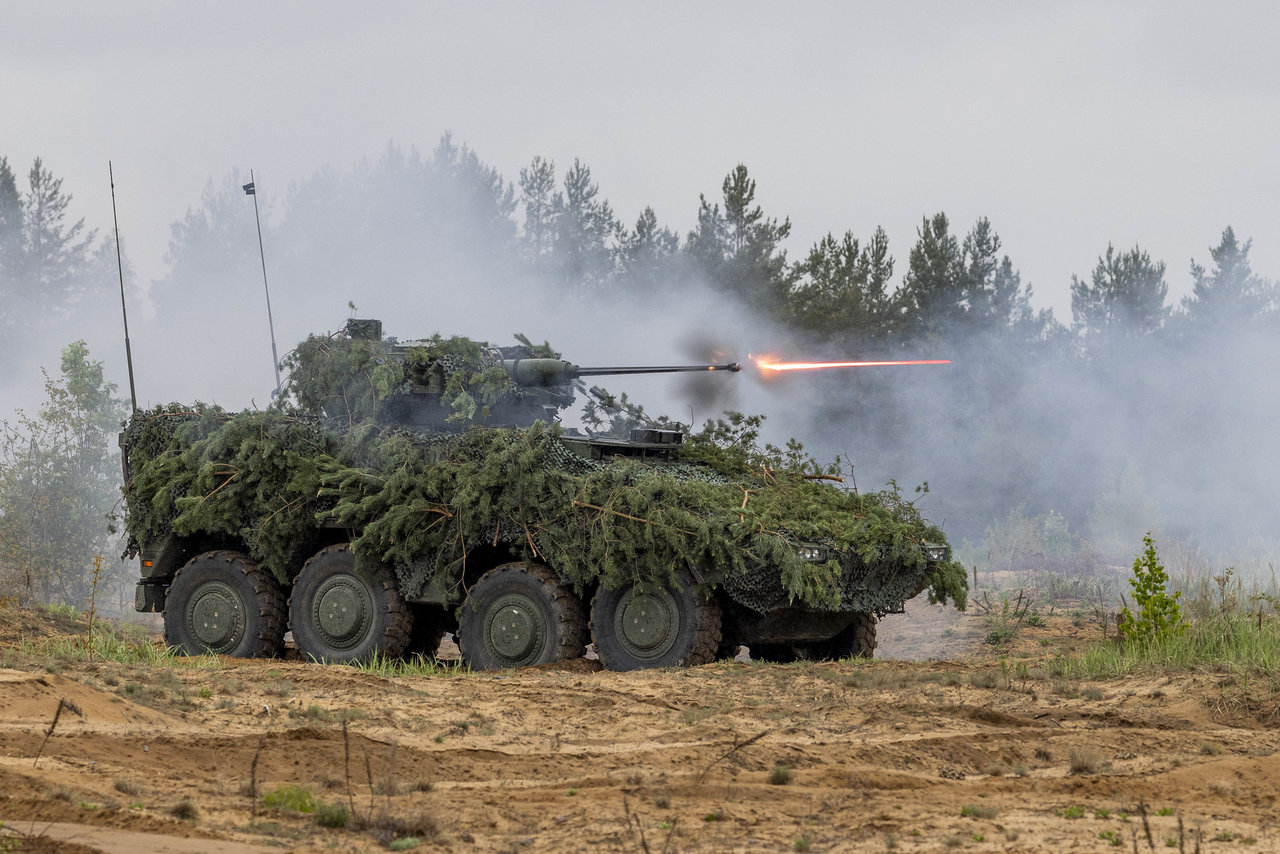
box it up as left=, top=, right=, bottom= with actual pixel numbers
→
left=120, top=320, right=965, bottom=670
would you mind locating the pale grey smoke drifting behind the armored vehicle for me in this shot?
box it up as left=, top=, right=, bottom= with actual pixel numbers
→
left=0, top=146, right=1280, bottom=581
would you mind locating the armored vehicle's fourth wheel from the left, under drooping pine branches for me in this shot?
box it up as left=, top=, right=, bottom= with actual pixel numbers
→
left=591, top=574, right=721, bottom=670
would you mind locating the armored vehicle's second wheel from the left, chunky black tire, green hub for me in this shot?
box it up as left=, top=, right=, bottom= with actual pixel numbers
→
left=289, top=543, right=412, bottom=663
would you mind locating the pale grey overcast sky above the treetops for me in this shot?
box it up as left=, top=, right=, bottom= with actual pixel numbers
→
left=0, top=0, right=1280, bottom=321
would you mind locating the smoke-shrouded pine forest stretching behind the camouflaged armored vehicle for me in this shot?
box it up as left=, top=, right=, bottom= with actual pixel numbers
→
left=0, top=145, right=1280, bottom=608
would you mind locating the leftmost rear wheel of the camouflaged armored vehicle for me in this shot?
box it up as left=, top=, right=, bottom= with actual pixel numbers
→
left=164, top=552, right=284, bottom=658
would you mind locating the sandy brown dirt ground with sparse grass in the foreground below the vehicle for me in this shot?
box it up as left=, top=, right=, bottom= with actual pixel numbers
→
left=0, top=603, right=1280, bottom=854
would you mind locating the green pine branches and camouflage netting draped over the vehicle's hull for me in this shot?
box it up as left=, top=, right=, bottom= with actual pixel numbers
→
left=127, top=327, right=966, bottom=611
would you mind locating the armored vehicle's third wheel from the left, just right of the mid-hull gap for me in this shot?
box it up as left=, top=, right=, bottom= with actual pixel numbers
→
left=457, top=563, right=586, bottom=670
